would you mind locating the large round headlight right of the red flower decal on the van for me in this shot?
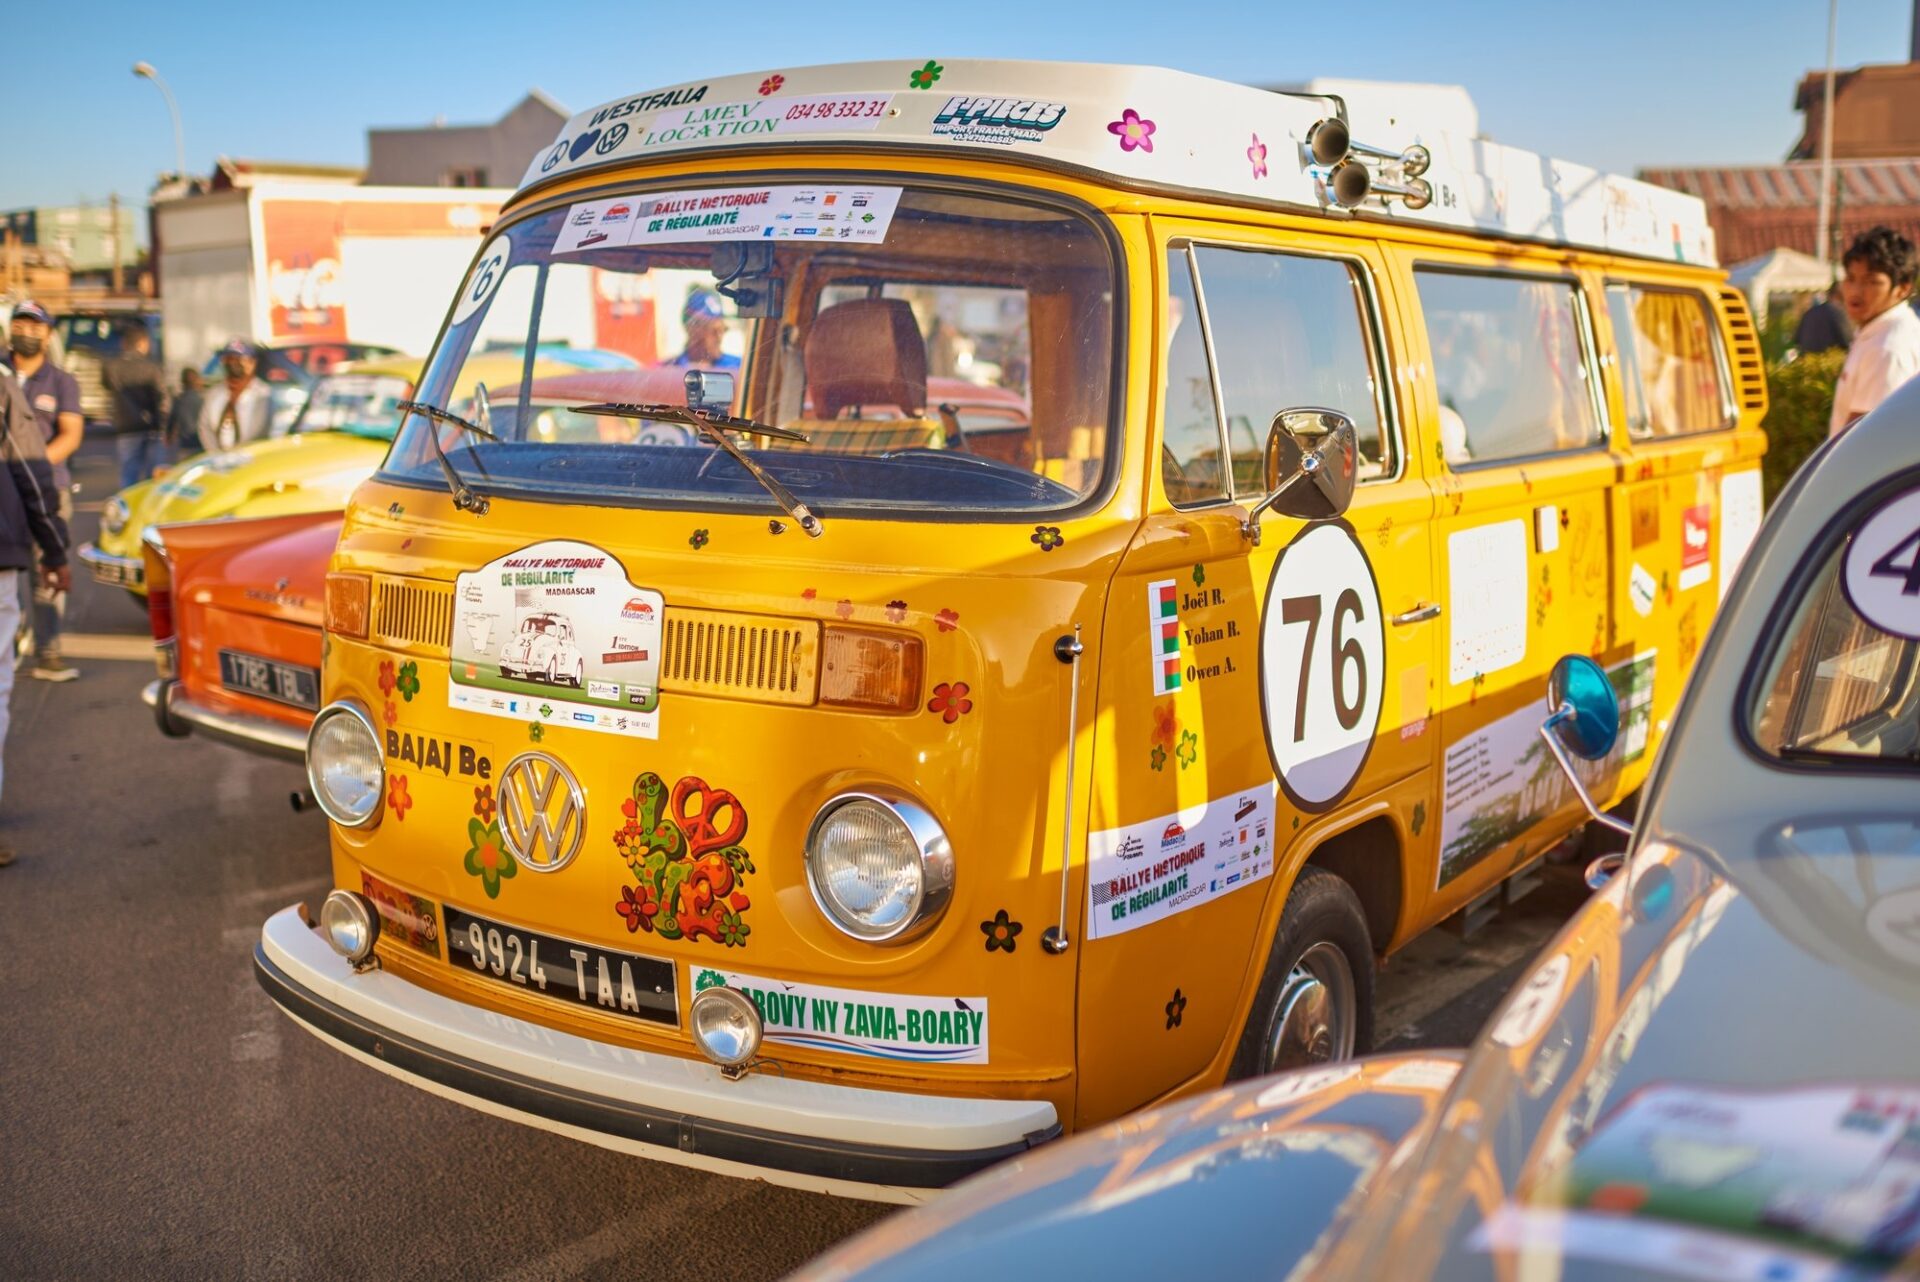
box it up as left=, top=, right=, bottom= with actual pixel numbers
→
left=806, top=793, right=954, bottom=942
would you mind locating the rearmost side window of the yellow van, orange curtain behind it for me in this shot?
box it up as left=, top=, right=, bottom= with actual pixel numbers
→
left=1607, top=284, right=1734, bottom=439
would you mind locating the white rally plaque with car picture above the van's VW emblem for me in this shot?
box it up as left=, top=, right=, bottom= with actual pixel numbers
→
left=447, top=541, right=666, bottom=739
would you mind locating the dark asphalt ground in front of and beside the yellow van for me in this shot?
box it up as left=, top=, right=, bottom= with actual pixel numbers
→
left=0, top=443, right=1580, bottom=1282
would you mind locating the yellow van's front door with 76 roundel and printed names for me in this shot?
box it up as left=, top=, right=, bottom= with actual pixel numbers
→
left=1079, top=221, right=1434, bottom=1119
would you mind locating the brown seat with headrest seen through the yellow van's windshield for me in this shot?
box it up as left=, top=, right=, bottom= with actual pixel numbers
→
left=770, top=297, right=947, bottom=455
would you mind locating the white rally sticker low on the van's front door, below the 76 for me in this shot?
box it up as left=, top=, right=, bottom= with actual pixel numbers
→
left=1087, top=783, right=1279, bottom=938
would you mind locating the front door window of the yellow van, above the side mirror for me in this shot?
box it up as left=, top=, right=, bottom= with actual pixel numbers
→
left=1194, top=246, right=1392, bottom=487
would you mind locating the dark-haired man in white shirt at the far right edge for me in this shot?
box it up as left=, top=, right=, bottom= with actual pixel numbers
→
left=1826, top=226, right=1920, bottom=436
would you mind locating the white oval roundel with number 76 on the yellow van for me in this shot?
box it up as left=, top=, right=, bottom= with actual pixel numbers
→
left=1260, top=522, right=1386, bottom=810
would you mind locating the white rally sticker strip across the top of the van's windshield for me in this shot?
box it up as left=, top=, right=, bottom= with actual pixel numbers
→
left=553, top=186, right=900, bottom=253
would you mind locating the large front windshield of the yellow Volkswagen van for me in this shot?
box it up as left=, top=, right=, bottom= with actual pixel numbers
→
left=384, top=175, right=1116, bottom=516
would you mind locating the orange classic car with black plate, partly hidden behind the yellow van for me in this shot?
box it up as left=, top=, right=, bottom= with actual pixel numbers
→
left=142, top=512, right=340, bottom=762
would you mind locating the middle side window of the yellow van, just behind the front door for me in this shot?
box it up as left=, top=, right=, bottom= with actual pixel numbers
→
left=1413, top=269, right=1605, bottom=466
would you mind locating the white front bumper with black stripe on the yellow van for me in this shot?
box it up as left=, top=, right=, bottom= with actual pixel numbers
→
left=253, top=906, right=1060, bottom=1201
